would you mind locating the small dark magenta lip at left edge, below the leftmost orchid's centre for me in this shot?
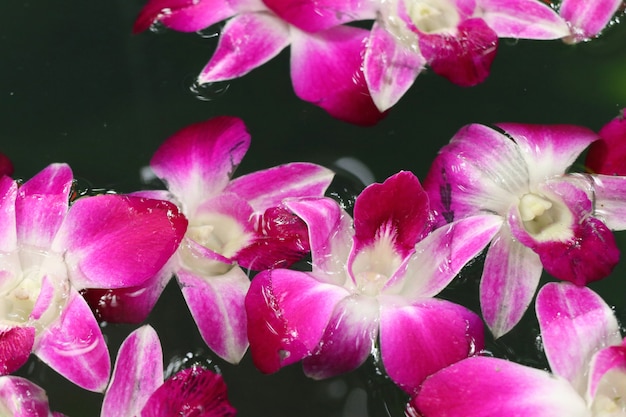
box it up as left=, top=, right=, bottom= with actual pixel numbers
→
left=0, top=326, right=35, bottom=375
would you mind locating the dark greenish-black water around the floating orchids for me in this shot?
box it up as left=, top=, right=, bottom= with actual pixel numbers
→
left=0, top=0, right=626, bottom=417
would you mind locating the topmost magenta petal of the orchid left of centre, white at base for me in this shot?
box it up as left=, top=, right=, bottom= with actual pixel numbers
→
left=150, top=116, right=250, bottom=213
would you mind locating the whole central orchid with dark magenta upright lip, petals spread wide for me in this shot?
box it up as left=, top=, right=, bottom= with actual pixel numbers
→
left=246, top=172, right=498, bottom=393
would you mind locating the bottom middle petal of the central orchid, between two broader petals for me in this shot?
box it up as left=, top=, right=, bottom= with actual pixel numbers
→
left=302, top=296, right=380, bottom=379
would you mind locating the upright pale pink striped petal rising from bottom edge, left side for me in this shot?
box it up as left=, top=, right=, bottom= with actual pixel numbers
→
left=100, top=326, right=163, bottom=417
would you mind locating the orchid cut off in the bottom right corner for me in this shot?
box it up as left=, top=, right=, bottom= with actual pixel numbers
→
left=412, top=282, right=626, bottom=417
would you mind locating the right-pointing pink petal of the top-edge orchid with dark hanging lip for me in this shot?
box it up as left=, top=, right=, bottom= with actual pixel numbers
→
left=480, top=0, right=569, bottom=39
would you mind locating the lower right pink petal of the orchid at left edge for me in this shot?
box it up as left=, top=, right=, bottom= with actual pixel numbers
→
left=33, top=289, right=111, bottom=392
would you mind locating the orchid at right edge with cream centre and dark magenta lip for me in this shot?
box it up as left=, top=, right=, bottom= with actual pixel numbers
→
left=424, top=123, right=626, bottom=337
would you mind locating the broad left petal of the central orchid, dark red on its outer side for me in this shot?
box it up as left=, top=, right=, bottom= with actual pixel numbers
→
left=245, top=269, right=348, bottom=373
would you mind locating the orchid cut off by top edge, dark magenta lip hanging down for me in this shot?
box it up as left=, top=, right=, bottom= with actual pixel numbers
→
left=358, top=0, right=569, bottom=111
